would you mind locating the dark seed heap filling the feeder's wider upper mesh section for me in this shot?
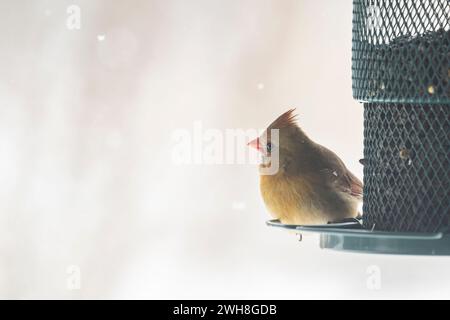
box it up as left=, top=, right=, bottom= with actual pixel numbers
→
left=353, top=28, right=450, bottom=102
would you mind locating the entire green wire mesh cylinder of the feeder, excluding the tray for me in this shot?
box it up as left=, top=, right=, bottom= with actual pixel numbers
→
left=352, top=0, right=450, bottom=232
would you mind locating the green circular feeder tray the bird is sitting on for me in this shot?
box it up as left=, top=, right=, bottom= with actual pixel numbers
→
left=266, top=219, right=450, bottom=256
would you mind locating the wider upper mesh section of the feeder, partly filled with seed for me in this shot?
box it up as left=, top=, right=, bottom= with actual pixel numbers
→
left=352, top=0, right=450, bottom=103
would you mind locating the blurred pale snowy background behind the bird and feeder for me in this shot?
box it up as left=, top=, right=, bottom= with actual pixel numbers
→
left=0, top=0, right=450, bottom=299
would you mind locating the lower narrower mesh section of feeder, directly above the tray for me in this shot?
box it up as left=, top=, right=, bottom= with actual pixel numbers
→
left=363, top=103, right=450, bottom=232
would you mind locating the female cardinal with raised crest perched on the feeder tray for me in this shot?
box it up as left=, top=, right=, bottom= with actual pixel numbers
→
left=249, top=109, right=363, bottom=225
